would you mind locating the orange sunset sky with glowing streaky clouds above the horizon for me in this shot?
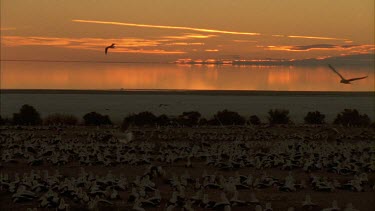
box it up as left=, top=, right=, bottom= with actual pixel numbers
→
left=1, top=0, right=374, bottom=62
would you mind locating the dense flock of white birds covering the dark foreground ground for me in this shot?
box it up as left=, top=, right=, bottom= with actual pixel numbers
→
left=0, top=127, right=375, bottom=211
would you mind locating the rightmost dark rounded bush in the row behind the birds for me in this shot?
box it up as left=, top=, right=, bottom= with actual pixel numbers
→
left=333, top=109, right=371, bottom=127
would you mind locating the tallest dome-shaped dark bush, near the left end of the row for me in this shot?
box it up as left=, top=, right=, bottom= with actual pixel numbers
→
left=13, top=104, right=42, bottom=125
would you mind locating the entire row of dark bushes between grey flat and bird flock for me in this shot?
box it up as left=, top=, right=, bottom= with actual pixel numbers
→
left=0, top=104, right=375, bottom=127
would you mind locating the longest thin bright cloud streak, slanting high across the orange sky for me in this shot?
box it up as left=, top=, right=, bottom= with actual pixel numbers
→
left=72, top=19, right=260, bottom=36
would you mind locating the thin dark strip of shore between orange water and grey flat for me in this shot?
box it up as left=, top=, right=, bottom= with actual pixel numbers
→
left=0, top=89, right=375, bottom=97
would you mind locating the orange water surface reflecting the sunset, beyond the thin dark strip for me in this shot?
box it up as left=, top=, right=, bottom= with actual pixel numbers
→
left=1, top=62, right=375, bottom=91
